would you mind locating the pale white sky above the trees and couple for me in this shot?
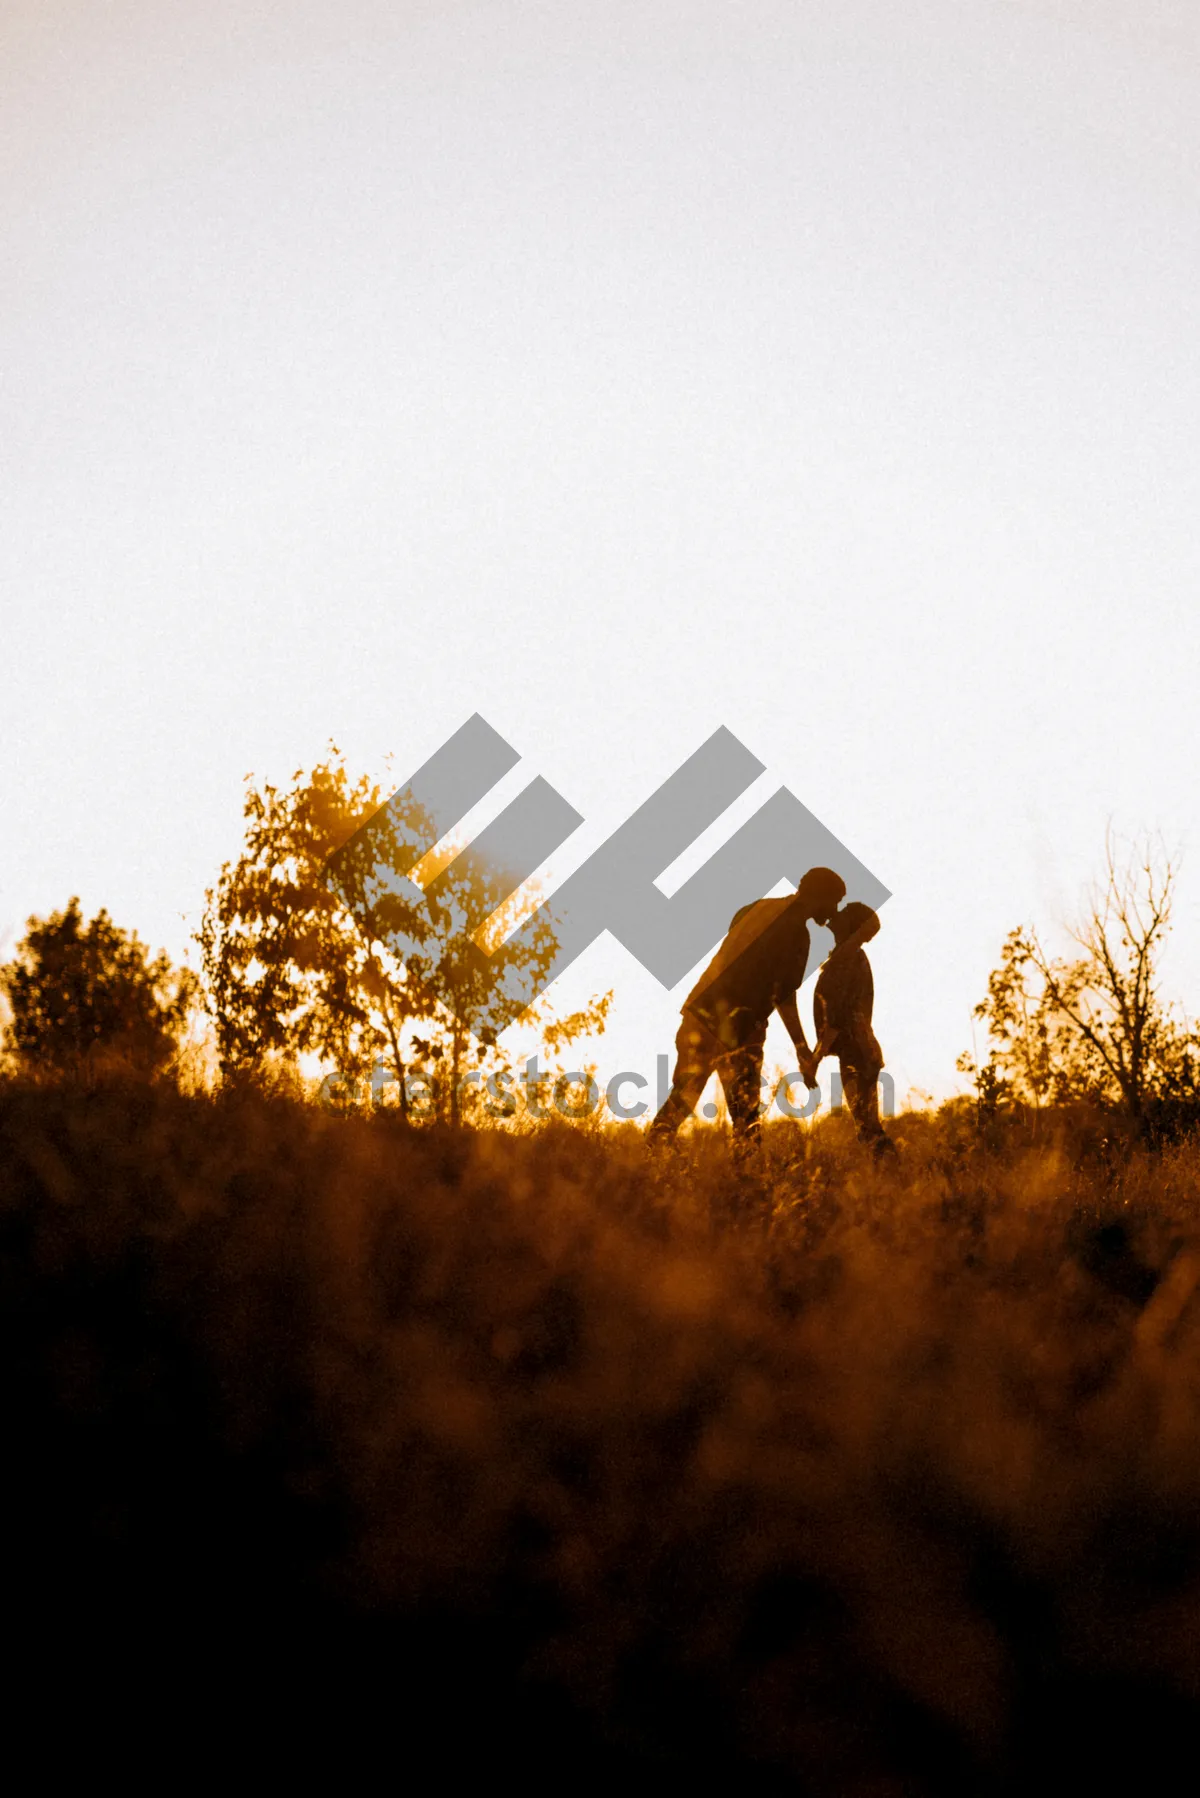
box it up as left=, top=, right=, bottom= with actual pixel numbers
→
left=0, top=0, right=1200, bottom=1097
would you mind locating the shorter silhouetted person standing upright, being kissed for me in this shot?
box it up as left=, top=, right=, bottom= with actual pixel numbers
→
left=802, top=903, right=896, bottom=1154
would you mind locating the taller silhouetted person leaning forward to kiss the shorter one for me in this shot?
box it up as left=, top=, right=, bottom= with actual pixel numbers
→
left=649, top=868, right=846, bottom=1140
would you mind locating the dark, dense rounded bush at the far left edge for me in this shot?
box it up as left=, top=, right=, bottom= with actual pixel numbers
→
left=0, top=897, right=198, bottom=1075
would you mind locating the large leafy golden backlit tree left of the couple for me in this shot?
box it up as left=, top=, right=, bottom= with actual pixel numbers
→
left=198, top=744, right=606, bottom=1122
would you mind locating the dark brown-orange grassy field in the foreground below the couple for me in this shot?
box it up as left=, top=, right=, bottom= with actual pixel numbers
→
left=0, top=1084, right=1200, bottom=1794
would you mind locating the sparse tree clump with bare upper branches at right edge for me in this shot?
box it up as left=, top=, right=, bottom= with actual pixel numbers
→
left=959, top=832, right=1196, bottom=1122
